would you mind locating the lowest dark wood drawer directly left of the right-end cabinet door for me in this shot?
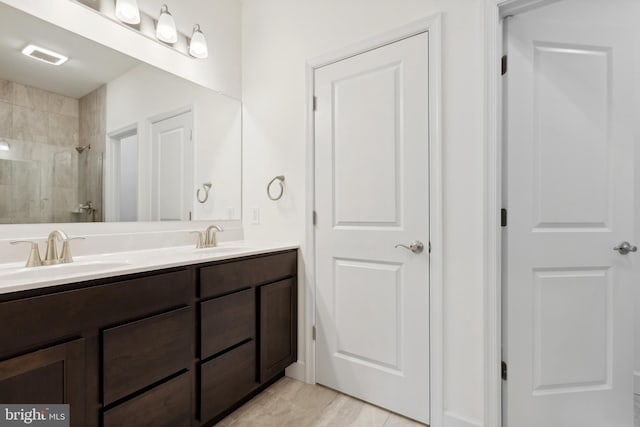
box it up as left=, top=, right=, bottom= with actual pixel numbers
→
left=200, top=340, right=257, bottom=422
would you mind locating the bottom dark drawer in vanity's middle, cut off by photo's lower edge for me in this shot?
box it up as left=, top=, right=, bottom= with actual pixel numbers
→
left=103, top=371, right=192, bottom=427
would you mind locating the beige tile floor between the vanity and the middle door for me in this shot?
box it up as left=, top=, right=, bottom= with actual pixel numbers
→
left=217, top=377, right=424, bottom=427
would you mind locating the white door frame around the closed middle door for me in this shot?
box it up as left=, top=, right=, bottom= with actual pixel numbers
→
left=304, top=13, right=444, bottom=427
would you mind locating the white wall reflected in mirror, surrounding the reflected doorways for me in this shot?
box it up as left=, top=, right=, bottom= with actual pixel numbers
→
left=107, top=64, right=242, bottom=221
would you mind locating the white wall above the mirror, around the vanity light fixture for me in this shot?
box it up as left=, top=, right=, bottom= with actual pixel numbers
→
left=2, top=0, right=241, bottom=98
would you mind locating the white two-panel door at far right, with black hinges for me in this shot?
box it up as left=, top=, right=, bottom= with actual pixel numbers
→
left=503, top=10, right=638, bottom=427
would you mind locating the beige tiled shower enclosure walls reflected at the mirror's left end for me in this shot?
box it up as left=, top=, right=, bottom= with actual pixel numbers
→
left=0, top=80, right=106, bottom=224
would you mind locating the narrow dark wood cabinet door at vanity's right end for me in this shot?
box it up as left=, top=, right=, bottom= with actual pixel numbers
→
left=259, top=278, right=297, bottom=382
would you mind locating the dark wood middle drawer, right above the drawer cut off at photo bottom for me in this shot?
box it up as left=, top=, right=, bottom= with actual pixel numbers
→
left=102, top=307, right=193, bottom=405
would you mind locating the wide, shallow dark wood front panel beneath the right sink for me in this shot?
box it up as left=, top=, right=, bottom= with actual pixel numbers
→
left=200, top=251, right=298, bottom=298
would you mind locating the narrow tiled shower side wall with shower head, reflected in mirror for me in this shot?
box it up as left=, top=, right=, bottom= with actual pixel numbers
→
left=78, top=85, right=107, bottom=222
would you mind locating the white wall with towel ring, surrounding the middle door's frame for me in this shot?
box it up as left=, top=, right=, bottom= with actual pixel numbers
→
left=242, top=0, right=484, bottom=426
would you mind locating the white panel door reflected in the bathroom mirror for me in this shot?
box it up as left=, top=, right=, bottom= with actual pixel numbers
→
left=152, top=111, right=194, bottom=221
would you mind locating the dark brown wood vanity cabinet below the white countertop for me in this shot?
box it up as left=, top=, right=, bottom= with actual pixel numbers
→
left=0, top=248, right=297, bottom=427
